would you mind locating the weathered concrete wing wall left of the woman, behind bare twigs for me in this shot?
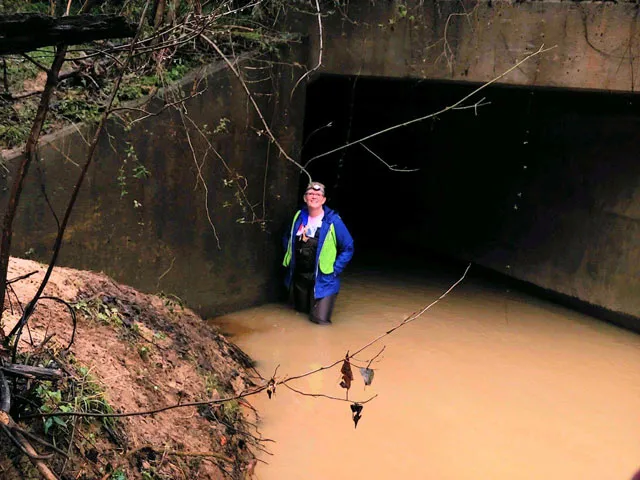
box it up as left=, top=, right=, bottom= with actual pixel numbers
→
left=2, top=55, right=304, bottom=316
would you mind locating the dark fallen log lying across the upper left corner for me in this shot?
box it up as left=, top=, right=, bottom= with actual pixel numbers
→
left=0, top=13, right=136, bottom=55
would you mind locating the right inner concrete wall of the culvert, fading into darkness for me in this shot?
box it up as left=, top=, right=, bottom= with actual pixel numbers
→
left=414, top=86, right=640, bottom=320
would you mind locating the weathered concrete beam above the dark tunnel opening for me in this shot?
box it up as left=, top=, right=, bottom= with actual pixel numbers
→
left=296, top=0, right=640, bottom=91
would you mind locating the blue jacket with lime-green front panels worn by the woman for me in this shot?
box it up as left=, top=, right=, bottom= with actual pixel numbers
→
left=282, top=206, right=353, bottom=298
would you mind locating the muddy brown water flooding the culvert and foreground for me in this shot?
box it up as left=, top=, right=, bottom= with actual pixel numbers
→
left=212, top=269, right=640, bottom=480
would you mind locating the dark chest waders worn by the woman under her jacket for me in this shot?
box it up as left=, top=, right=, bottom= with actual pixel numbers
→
left=291, top=229, right=337, bottom=325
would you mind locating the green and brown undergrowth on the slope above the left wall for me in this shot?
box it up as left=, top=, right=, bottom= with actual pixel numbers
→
left=0, top=0, right=308, bottom=150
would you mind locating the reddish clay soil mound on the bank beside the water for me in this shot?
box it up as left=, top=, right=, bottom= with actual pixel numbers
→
left=0, top=258, right=256, bottom=480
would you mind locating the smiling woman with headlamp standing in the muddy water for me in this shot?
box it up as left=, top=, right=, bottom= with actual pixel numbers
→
left=282, top=182, right=353, bottom=325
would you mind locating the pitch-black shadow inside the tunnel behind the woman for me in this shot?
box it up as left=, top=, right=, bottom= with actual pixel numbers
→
left=300, top=75, right=640, bottom=330
